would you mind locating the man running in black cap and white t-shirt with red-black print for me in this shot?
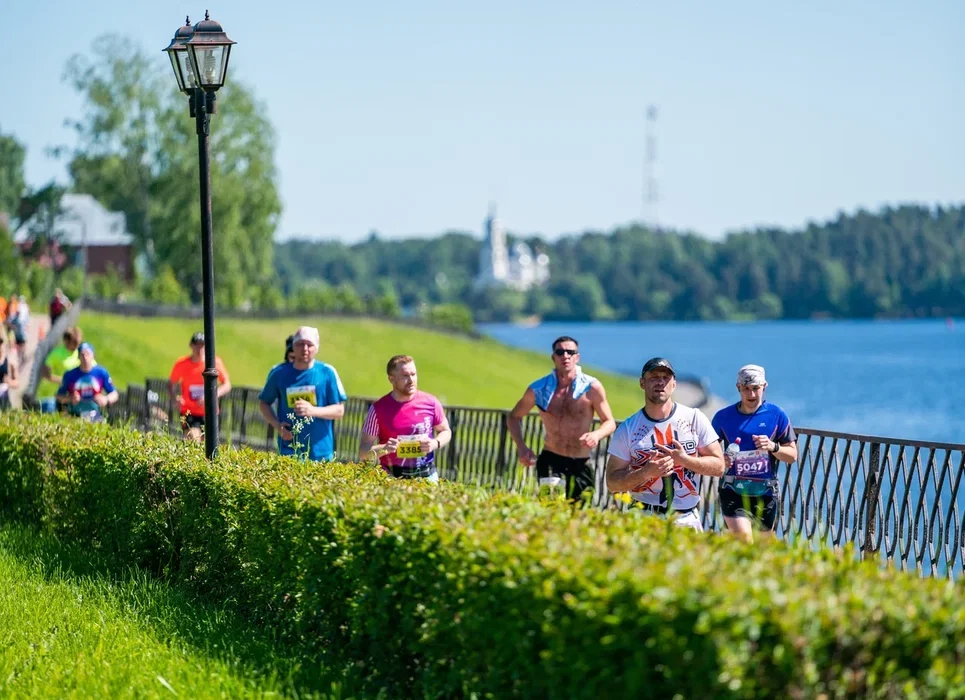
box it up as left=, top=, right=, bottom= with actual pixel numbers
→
left=606, top=357, right=724, bottom=530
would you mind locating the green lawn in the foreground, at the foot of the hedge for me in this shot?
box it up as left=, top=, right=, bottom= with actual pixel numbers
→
left=0, top=525, right=368, bottom=698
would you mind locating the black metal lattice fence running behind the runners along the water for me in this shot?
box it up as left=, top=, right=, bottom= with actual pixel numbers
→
left=101, top=379, right=965, bottom=578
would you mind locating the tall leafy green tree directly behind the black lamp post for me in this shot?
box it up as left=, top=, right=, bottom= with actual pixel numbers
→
left=60, top=36, right=281, bottom=307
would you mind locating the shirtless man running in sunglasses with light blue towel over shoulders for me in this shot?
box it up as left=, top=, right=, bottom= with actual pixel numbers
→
left=506, top=335, right=616, bottom=501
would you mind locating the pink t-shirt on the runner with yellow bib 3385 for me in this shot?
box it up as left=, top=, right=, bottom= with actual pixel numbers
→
left=362, top=391, right=446, bottom=470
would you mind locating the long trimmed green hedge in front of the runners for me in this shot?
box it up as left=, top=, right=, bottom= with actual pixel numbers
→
left=0, top=414, right=965, bottom=698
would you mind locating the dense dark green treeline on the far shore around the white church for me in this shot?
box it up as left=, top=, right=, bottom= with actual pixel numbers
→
left=275, top=206, right=965, bottom=321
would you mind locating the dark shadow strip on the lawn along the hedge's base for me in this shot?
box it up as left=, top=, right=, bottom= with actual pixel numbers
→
left=0, top=524, right=378, bottom=698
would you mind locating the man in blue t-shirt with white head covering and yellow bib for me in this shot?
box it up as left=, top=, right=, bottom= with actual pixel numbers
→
left=258, top=326, right=348, bottom=462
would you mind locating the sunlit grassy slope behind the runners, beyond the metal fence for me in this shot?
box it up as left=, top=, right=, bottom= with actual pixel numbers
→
left=68, top=312, right=643, bottom=419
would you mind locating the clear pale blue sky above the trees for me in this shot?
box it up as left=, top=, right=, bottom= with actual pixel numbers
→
left=0, top=0, right=965, bottom=241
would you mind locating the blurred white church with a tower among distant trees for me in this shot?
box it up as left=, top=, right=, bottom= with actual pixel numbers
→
left=474, top=206, right=550, bottom=291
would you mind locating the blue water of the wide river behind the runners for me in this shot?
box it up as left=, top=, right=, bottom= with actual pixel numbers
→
left=480, top=320, right=965, bottom=443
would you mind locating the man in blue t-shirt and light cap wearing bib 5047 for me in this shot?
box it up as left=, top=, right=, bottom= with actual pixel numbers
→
left=712, top=365, right=797, bottom=541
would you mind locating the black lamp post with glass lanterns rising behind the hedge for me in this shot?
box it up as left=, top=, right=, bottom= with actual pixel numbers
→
left=164, top=10, right=235, bottom=459
